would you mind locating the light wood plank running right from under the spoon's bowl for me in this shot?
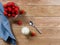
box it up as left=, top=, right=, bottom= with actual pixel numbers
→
left=13, top=16, right=60, bottom=27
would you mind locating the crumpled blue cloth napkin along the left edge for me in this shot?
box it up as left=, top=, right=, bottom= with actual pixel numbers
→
left=0, top=2, right=16, bottom=45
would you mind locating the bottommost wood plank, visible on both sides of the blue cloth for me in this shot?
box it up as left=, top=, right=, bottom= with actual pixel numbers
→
left=0, top=38, right=60, bottom=45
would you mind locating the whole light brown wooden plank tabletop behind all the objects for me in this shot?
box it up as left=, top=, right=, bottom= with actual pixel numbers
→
left=0, top=0, right=60, bottom=45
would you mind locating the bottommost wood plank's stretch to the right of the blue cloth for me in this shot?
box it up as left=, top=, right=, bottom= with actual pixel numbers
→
left=16, top=38, right=60, bottom=45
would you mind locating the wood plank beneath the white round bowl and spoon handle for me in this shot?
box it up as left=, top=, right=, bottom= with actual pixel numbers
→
left=13, top=26, right=60, bottom=39
